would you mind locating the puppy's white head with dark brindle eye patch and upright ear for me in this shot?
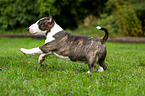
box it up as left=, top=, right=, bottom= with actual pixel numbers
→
left=28, top=11, right=54, bottom=35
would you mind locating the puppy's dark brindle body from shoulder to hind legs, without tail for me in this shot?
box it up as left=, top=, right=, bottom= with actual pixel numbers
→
left=40, top=31, right=107, bottom=71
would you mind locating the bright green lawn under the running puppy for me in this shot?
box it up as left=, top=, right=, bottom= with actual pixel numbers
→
left=0, top=38, right=145, bottom=96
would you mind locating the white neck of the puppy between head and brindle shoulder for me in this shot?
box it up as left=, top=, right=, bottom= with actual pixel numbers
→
left=45, top=22, right=63, bottom=44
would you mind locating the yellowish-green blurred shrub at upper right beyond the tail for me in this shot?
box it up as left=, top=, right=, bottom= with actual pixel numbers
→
left=107, top=0, right=143, bottom=36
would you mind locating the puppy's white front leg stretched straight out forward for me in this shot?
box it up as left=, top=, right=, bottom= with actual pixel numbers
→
left=20, top=47, right=43, bottom=55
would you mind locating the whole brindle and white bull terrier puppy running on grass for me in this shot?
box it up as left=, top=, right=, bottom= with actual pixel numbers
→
left=20, top=12, right=108, bottom=73
